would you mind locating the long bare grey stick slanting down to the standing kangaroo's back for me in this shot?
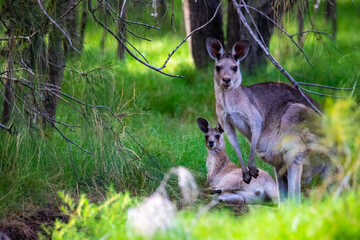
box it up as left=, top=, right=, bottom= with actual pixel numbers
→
left=232, top=0, right=322, bottom=114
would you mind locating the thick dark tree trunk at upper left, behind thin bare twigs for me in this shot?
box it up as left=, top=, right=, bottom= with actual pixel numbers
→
left=44, top=1, right=69, bottom=122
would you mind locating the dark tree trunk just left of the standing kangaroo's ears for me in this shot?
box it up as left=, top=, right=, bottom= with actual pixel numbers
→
left=184, top=0, right=224, bottom=68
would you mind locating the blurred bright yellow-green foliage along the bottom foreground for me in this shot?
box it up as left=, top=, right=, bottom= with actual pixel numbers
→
left=48, top=190, right=360, bottom=240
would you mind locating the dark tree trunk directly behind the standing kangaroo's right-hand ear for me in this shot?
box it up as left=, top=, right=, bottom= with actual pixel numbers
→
left=227, top=0, right=281, bottom=72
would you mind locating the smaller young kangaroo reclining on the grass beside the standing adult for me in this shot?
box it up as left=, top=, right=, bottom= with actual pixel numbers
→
left=197, top=118, right=278, bottom=205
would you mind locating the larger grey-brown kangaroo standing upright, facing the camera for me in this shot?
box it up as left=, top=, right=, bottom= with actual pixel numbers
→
left=206, top=38, right=328, bottom=202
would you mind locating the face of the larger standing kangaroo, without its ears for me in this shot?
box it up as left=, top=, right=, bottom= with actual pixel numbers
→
left=214, top=55, right=242, bottom=89
